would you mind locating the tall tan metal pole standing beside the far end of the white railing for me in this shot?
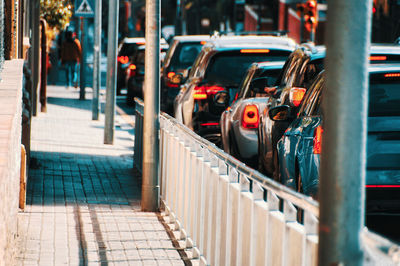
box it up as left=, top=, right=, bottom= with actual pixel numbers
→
left=142, top=0, right=161, bottom=211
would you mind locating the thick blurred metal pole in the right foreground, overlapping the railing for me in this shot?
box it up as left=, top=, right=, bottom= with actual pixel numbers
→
left=318, top=0, right=372, bottom=265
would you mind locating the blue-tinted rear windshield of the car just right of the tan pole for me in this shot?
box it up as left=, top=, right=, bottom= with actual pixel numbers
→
left=170, top=42, right=203, bottom=70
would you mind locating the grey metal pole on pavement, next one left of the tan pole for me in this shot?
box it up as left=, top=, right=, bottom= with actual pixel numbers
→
left=104, top=0, right=119, bottom=144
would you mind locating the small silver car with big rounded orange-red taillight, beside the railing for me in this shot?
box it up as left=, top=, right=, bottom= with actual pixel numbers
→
left=220, top=61, right=285, bottom=167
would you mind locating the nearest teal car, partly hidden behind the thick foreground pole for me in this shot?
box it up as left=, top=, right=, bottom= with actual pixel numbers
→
left=269, top=65, right=400, bottom=212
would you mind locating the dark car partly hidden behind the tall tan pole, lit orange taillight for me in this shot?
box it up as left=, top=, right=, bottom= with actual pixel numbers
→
left=126, top=41, right=169, bottom=105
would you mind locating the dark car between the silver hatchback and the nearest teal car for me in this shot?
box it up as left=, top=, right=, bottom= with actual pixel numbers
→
left=258, top=45, right=325, bottom=181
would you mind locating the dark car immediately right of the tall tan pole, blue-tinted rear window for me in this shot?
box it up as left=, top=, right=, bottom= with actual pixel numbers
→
left=160, top=35, right=211, bottom=114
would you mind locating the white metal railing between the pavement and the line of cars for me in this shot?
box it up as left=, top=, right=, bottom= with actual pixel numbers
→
left=135, top=101, right=400, bottom=266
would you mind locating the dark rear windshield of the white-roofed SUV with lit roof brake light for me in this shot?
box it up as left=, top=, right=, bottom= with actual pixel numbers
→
left=204, top=51, right=290, bottom=87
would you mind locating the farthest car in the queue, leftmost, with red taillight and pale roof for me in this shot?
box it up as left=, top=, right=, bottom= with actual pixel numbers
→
left=117, top=37, right=146, bottom=95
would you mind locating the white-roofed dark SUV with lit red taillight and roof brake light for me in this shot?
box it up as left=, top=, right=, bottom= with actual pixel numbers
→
left=174, top=36, right=296, bottom=144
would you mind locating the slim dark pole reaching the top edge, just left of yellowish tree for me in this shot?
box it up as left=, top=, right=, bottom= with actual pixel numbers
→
left=31, top=0, right=40, bottom=116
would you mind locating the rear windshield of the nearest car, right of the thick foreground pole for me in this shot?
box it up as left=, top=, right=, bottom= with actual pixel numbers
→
left=369, top=73, right=400, bottom=116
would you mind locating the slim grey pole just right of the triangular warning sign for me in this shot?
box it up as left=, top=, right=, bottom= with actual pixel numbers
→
left=92, top=0, right=101, bottom=120
